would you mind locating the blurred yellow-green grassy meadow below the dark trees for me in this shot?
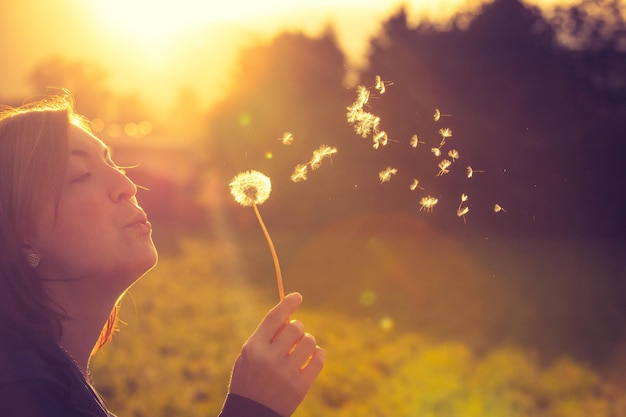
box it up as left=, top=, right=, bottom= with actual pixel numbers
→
left=92, top=218, right=626, bottom=417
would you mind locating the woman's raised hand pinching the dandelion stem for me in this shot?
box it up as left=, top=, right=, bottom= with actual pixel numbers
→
left=229, top=293, right=325, bottom=416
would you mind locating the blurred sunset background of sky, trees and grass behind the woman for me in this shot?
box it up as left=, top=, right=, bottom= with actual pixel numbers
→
left=0, top=0, right=626, bottom=417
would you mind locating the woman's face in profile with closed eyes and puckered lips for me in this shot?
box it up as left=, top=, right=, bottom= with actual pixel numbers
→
left=31, top=125, right=157, bottom=299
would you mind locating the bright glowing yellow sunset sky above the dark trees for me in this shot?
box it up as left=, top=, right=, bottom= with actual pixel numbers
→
left=0, top=0, right=569, bottom=110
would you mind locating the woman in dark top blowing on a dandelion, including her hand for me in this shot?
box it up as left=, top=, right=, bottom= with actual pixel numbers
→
left=0, top=95, right=324, bottom=417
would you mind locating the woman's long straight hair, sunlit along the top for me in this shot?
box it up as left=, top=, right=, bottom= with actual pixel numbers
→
left=0, top=91, right=118, bottom=350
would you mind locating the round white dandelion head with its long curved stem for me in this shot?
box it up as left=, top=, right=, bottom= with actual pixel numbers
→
left=228, top=170, right=285, bottom=300
